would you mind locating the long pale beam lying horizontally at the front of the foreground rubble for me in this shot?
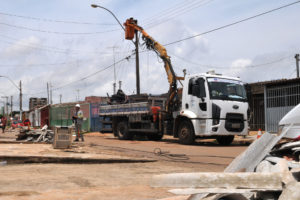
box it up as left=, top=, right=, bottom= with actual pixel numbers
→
left=152, top=172, right=282, bottom=190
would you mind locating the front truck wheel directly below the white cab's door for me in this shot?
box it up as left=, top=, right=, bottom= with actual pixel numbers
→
left=178, top=120, right=195, bottom=145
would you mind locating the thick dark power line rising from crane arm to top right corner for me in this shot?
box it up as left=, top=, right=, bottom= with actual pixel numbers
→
left=164, top=1, right=300, bottom=46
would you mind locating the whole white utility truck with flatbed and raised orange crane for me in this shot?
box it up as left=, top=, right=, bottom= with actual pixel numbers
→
left=99, top=18, right=250, bottom=145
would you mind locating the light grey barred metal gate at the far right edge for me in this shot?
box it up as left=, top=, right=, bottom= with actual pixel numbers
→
left=265, top=83, right=300, bottom=132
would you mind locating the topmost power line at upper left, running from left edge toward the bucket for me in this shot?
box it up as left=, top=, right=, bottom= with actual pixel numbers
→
left=0, top=12, right=117, bottom=26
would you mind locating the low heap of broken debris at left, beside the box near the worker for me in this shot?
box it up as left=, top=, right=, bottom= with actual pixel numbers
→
left=16, top=125, right=54, bottom=143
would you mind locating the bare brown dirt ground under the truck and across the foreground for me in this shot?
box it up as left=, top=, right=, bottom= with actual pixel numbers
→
left=0, top=130, right=249, bottom=200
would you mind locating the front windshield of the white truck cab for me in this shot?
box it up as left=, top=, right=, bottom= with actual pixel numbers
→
left=207, top=78, right=247, bottom=101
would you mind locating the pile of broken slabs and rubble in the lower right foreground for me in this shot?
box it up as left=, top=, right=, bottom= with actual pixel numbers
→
left=152, top=126, right=300, bottom=200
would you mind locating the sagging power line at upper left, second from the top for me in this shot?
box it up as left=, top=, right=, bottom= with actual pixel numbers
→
left=0, top=22, right=121, bottom=35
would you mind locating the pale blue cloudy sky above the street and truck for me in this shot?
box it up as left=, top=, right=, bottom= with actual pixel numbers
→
left=0, top=0, right=300, bottom=110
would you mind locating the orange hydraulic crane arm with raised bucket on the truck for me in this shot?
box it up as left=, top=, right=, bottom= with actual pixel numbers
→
left=124, top=18, right=184, bottom=112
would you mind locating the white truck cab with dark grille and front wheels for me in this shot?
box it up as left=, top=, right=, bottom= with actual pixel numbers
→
left=175, top=72, right=249, bottom=145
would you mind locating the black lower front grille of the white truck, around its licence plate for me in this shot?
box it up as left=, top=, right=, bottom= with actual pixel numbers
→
left=225, top=113, right=244, bottom=132
